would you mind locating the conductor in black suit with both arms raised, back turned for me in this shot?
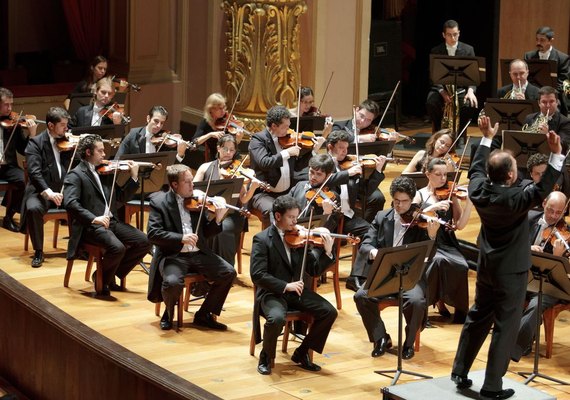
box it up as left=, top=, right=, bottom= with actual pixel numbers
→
left=451, top=117, right=564, bottom=399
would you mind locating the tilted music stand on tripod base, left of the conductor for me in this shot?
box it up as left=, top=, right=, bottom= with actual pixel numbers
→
left=364, top=240, right=435, bottom=386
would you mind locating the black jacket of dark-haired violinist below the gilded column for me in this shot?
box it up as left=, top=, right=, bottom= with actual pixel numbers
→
left=249, top=128, right=296, bottom=189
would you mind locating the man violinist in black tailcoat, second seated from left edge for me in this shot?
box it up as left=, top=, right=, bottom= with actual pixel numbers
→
left=20, top=107, right=69, bottom=268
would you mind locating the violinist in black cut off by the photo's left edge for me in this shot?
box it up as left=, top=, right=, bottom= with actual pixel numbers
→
left=0, top=87, right=38, bottom=232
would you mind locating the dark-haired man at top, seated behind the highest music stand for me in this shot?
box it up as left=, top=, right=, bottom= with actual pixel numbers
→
left=426, top=19, right=477, bottom=132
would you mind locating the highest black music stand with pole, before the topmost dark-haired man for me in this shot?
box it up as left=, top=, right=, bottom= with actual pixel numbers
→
left=430, top=54, right=486, bottom=139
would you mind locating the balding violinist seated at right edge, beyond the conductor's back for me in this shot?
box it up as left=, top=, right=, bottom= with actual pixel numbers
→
left=511, top=191, right=569, bottom=362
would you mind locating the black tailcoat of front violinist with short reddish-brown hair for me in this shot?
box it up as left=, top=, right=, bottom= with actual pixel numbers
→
left=147, top=190, right=222, bottom=303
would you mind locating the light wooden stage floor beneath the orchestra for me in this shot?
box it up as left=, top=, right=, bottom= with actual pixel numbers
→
left=0, top=141, right=570, bottom=399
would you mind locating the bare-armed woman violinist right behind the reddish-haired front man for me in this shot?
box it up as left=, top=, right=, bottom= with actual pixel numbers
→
left=194, top=134, right=259, bottom=265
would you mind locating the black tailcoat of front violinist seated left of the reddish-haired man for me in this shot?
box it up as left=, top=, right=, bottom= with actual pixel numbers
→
left=63, top=161, right=139, bottom=259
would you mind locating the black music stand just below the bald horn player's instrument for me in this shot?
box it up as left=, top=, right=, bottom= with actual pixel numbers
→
left=485, top=99, right=538, bottom=131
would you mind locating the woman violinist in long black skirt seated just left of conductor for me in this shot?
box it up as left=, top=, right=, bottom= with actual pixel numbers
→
left=414, top=158, right=473, bottom=324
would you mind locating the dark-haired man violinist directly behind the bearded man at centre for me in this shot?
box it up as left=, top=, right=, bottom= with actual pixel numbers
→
left=327, top=131, right=386, bottom=291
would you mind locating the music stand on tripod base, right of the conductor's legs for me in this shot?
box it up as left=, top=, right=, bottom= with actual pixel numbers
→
left=519, top=251, right=570, bottom=385
